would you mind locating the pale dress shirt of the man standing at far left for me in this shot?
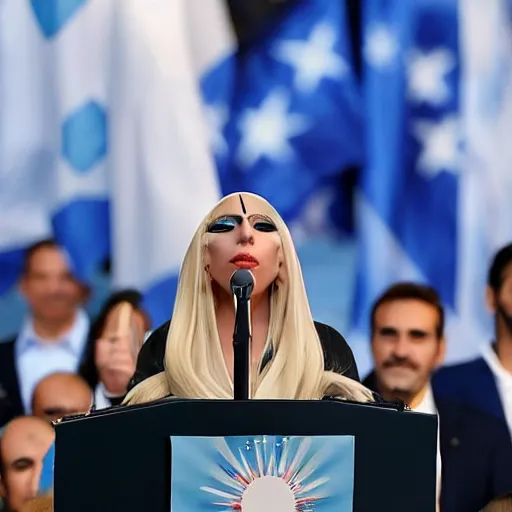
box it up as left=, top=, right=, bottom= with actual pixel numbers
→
left=15, top=310, right=89, bottom=414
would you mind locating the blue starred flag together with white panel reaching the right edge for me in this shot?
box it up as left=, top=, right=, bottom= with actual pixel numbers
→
left=351, top=0, right=512, bottom=372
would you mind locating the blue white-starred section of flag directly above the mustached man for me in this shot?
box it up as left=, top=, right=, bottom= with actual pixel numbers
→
left=353, top=0, right=461, bottom=367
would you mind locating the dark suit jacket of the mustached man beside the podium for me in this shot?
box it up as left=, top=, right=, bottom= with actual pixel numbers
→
left=363, top=372, right=512, bottom=512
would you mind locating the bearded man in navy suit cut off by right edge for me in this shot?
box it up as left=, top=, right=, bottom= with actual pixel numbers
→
left=433, top=244, right=512, bottom=434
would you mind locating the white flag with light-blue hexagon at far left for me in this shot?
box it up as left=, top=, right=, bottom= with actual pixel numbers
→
left=0, top=0, right=111, bottom=293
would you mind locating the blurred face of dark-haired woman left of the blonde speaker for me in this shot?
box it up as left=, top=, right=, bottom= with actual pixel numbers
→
left=95, top=302, right=146, bottom=395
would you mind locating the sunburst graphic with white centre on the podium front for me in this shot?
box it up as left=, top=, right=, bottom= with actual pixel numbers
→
left=200, top=436, right=329, bottom=512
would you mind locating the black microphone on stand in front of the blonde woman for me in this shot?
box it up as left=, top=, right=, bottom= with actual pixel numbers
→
left=229, top=268, right=254, bottom=400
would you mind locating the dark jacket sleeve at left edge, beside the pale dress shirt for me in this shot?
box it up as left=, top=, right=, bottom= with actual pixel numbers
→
left=0, top=337, right=24, bottom=427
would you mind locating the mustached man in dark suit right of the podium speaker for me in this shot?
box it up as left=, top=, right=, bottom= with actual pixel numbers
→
left=364, top=283, right=512, bottom=512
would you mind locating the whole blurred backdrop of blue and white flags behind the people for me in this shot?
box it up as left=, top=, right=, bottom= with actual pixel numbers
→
left=0, top=0, right=512, bottom=375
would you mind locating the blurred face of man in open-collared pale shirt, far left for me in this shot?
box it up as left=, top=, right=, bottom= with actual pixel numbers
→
left=21, top=247, right=85, bottom=322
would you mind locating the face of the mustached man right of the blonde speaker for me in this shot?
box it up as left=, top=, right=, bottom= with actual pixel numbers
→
left=372, top=299, right=445, bottom=407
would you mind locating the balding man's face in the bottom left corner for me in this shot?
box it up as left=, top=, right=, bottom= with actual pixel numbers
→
left=1, top=417, right=54, bottom=512
